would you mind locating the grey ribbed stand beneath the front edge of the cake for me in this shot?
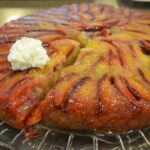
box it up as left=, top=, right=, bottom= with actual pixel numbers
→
left=0, top=122, right=150, bottom=150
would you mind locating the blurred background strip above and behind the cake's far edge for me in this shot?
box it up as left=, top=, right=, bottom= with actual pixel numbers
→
left=0, top=0, right=150, bottom=25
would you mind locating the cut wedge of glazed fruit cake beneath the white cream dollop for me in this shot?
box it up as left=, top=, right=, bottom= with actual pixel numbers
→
left=0, top=31, right=79, bottom=128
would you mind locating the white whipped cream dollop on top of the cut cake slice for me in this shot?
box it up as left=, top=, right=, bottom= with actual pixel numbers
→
left=8, top=37, right=50, bottom=70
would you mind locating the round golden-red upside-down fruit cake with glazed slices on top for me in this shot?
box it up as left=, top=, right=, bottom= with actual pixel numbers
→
left=0, top=3, right=150, bottom=137
